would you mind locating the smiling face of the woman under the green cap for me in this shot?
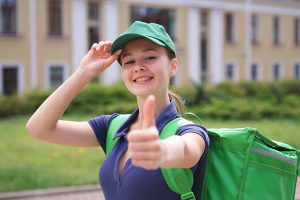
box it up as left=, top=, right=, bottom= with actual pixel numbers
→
left=121, top=38, right=178, bottom=97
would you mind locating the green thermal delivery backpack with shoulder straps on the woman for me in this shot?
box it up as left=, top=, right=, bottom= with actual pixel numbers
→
left=106, top=115, right=300, bottom=200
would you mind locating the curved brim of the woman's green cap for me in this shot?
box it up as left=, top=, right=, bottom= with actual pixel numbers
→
left=110, top=33, right=166, bottom=54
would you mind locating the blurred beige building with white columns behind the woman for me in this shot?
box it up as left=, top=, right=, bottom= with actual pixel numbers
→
left=0, top=0, right=300, bottom=94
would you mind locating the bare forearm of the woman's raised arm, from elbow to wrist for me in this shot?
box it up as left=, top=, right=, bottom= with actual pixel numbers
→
left=26, top=69, right=91, bottom=135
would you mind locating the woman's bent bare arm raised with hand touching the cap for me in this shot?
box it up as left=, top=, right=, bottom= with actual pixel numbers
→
left=26, top=41, right=120, bottom=146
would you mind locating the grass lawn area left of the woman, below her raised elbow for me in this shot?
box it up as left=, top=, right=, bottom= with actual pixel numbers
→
left=0, top=117, right=104, bottom=192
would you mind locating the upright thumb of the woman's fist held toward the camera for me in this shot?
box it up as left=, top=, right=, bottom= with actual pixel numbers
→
left=142, top=95, right=155, bottom=128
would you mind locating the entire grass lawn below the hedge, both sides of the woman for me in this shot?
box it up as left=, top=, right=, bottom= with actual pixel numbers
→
left=0, top=116, right=300, bottom=192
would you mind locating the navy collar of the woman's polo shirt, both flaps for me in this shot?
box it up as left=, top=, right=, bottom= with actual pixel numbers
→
left=115, top=100, right=179, bottom=137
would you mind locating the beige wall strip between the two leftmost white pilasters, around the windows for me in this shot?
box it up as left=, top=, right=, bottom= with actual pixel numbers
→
left=36, top=0, right=73, bottom=87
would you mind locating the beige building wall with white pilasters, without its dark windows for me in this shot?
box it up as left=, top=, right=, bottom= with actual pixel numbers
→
left=0, top=0, right=300, bottom=95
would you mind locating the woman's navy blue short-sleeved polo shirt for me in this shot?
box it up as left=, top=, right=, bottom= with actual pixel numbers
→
left=88, top=102, right=209, bottom=200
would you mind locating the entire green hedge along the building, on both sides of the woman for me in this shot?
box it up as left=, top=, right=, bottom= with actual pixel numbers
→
left=0, top=81, right=300, bottom=119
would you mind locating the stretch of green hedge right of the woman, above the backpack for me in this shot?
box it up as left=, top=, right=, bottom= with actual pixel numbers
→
left=175, top=80, right=300, bottom=120
